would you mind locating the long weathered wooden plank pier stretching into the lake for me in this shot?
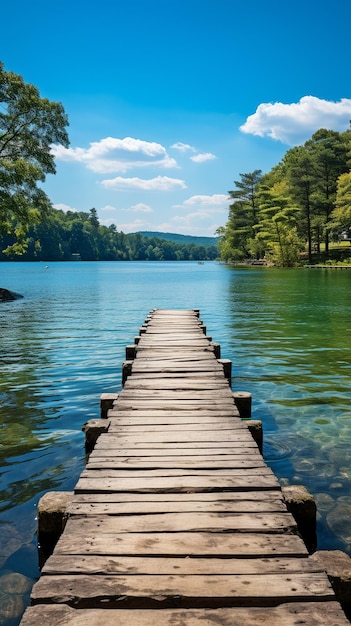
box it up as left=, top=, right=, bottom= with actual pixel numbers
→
left=21, top=310, right=349, bottom=626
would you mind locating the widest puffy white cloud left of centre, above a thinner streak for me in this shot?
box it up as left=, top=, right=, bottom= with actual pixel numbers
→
left=51, top=137, right=177, bottom=174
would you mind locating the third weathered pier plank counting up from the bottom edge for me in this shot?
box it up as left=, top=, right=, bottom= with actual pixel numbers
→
left=42, top=553, right=321, bottom=576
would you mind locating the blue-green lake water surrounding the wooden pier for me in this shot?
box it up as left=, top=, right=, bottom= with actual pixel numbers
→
left=0, top=262, right=351, bottom=626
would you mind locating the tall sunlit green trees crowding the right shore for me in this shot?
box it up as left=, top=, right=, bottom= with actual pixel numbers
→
left=217, top=128, right=351, bottom=266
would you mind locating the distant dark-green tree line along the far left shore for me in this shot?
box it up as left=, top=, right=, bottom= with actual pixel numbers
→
left=0, top=208, right=219, bottom=261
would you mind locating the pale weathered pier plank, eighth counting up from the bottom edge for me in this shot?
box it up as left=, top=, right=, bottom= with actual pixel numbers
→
left=75, top=470, right=280, bottom=493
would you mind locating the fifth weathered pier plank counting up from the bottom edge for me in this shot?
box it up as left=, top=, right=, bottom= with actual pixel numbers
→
left=66, top=512, right=296, bottom=536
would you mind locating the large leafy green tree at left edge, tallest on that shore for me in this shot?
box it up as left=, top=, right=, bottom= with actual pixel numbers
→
left=0, top=62, right=69, bottom=251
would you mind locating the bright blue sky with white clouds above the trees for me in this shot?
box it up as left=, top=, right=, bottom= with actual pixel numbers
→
left=0, top=0, right=351, bottom=236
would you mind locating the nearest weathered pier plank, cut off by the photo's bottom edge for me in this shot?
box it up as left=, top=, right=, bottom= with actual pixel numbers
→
left=21, top=602, right=349, bottom=626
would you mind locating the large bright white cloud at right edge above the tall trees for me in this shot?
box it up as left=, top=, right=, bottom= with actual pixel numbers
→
left=240, top=96, right=351, bottom=145
